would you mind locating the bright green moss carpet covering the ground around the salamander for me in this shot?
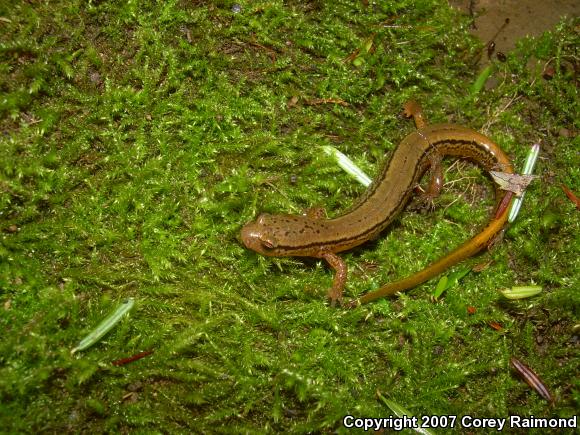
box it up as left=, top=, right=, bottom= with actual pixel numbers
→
left=0, top=0, right=580, bottom=433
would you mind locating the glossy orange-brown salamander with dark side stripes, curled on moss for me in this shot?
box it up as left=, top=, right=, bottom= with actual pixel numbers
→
left=241, top=102, right=513, bottom=306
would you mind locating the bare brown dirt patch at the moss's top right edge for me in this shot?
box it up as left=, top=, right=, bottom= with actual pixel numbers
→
left=450, top=0, right=580, bottom=60
